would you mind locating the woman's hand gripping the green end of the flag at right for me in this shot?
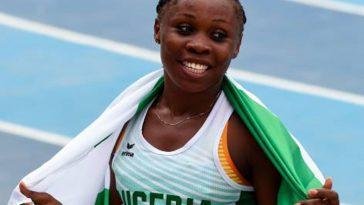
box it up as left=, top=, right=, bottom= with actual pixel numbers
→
left=297, top=178, right=340, bottom=205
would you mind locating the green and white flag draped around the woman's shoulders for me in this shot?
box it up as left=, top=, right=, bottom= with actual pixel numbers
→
left=8, top=70, right=324, bottom=205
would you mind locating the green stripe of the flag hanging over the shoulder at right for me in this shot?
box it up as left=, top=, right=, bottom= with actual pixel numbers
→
left=223, top=77, right=322, bottom=204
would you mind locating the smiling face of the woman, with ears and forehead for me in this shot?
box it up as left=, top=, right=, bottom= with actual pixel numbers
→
left=154, top=0, right=241, bottom=92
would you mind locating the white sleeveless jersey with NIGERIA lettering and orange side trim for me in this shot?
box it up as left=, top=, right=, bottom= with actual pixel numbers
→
left=112, top=93, right=254, bottom=205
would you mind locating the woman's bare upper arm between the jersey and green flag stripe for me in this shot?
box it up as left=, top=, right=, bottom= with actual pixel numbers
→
left=228, top=114, right=281, bottom=205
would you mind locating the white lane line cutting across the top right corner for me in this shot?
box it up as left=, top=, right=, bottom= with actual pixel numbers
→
left=285, top=0, right=364, bottom=16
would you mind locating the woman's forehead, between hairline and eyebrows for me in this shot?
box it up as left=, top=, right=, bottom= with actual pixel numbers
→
left=165, top=0, right=237, bottom=21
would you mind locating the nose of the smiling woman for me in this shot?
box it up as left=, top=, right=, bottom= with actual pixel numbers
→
left=186, top=34, right=211, bottom=55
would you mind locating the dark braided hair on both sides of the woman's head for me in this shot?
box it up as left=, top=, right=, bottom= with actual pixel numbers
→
left=156, top=0, right=246, bottom=36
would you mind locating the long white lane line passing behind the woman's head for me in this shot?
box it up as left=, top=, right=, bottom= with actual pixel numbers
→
left=0, top=13, right=364, bottom=106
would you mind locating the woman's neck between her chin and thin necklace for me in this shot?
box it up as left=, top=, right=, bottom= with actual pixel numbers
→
left=158, top=79, right=222, bottom=117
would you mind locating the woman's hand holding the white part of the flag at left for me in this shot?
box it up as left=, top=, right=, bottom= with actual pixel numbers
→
left=19, top=182, right=62, bottom=205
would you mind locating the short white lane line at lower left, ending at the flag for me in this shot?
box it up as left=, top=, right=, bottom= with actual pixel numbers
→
left=0, top=120, right=71, bottom=146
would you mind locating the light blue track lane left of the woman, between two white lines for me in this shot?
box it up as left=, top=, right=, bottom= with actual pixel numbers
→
left=0, top=26, right=160, bottom=136
